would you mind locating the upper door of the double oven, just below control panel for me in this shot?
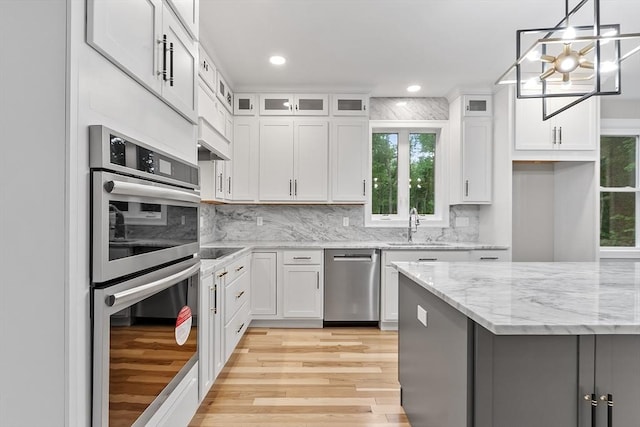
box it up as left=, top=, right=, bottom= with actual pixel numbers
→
left=91, top=171, right=200, bottom=283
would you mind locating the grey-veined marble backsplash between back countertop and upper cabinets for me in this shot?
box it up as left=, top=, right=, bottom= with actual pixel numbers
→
left=200, top=204, right=479, bottom=243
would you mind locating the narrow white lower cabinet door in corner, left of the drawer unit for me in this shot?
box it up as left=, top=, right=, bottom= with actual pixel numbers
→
left=251, top=252, right=277, bottom=318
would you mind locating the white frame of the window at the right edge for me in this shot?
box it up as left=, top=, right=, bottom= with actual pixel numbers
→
left=598, top=119, right=640, bottom=259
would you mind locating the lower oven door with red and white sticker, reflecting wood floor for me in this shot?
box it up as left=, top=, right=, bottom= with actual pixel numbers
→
left=92, top=258, right=200, bottom=427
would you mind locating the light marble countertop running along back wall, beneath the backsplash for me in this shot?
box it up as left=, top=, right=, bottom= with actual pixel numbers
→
left=201, top=241, right=508, bottom=275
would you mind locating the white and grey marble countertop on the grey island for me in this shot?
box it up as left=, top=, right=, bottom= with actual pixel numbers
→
left=394, top=262, right=640, bottom=335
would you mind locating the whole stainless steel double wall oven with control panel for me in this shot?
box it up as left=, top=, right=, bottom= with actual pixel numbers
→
left=89, top=126, right=200, bottom=426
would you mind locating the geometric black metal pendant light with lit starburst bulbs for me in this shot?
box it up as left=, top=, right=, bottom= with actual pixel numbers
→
left=496, top=0, right=640, bottom=120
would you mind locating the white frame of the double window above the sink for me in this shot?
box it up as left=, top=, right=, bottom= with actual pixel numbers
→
left=365, top=120, right=449, bottom=228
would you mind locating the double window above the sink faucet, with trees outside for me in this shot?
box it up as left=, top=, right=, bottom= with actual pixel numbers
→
left=367, top=121, right=448, bottom=227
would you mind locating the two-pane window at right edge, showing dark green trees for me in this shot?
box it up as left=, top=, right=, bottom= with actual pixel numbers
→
left=600, top=135, right=640, bottom=248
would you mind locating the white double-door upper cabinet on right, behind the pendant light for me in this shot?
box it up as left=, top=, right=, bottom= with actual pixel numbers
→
left=514, top=93, right=598, bottom=157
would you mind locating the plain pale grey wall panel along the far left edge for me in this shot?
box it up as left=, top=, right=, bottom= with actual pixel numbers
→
left=0, top=0, right=68, bottom=427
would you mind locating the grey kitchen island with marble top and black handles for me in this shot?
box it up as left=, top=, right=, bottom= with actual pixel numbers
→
left=396, top=262, right=640, bottom=427
